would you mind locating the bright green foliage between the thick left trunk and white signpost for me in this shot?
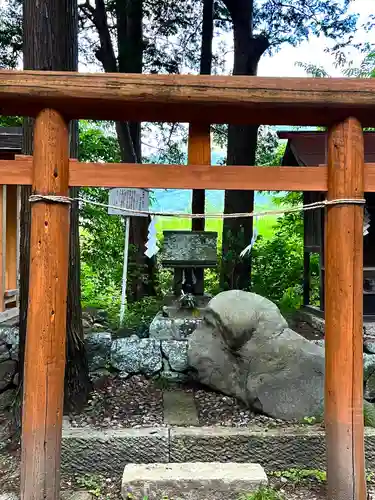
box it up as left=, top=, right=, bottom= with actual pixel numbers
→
left=79, top=121, right=153, bottom=316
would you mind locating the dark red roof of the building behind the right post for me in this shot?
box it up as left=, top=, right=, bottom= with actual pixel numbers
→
left=278, top=131, right=375, bottom=166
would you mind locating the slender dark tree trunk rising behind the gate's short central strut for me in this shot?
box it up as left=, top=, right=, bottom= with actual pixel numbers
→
left=191, top=0, right=214, bottom=231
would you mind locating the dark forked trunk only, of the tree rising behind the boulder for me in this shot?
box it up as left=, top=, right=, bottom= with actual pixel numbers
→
left=221, top=0, right=269, bottom=290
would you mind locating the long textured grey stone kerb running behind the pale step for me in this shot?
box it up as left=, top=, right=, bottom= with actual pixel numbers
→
left=62, top=426, right=375, bottom=475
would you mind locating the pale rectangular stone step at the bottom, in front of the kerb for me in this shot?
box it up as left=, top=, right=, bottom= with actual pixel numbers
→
left=122, top=462, right=268, bottom=500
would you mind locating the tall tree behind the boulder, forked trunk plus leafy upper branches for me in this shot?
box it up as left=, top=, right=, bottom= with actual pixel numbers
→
left=222, top=0, right=357, bottom=289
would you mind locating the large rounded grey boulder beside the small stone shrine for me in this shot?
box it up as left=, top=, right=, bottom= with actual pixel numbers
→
left=188, top=290, right=324, bottom=420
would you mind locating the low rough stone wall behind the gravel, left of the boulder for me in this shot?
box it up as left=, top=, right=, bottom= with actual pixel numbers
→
left=0, top=313, right=197, bottom=411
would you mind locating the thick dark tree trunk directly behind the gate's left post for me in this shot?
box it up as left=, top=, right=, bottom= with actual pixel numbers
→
left=20, top=0, right=90, bottom=420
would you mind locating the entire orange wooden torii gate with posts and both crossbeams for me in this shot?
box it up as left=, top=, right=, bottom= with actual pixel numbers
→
left=0, top=71, right=375, bottom=500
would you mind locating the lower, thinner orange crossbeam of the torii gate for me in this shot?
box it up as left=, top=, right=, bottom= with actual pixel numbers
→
left=5, top=155, right=375, bottom=193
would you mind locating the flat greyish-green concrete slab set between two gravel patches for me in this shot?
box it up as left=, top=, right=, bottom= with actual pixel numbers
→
left=163, top=390, right=199, bottom=426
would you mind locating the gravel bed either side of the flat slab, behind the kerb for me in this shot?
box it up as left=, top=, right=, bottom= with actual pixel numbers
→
left=69, top=375, right=293, bottom=429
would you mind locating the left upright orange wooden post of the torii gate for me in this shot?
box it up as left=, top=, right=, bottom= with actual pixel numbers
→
left=21, top=109, right=69, bottom=500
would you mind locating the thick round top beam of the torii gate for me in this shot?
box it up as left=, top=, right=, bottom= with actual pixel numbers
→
left=0, top=70, right=375, bottom=126
